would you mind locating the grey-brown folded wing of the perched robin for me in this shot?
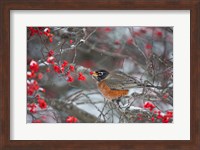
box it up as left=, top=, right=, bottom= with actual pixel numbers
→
left=104, top=71, right=141, bottom=90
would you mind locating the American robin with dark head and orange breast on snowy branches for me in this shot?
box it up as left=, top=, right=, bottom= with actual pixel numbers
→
left=91, top=70, right=161, bottom=100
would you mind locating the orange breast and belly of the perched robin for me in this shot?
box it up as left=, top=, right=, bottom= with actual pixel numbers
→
left=98, top=81, right=129, bottom=100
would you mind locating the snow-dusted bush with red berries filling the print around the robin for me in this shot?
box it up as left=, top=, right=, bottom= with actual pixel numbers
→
left=27, top=27, right=173, bottom=123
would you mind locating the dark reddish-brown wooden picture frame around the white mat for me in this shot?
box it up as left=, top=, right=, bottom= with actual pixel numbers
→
left=0, top=0, right=200, bottom=150
